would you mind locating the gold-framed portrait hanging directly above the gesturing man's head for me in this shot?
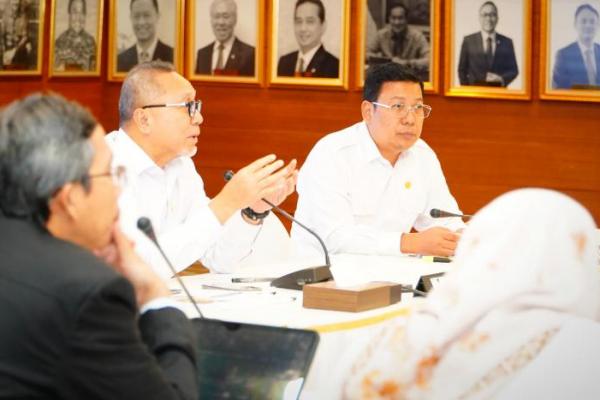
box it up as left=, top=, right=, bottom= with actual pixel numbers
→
left=108, top=0, right=183, bottom=81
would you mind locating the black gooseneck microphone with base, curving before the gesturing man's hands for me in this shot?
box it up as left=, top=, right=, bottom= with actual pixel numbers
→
left=223, top=170, right=333, bottom=290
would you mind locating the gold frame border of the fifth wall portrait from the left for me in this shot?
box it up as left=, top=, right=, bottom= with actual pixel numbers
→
left=267, top=0, right=351, bottom=89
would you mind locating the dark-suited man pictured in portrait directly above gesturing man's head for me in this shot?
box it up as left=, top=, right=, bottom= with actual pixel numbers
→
left=117, top=0, right=173, bottom=72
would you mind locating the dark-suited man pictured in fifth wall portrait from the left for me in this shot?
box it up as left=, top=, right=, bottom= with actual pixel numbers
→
left=277, top=0, right=340, bottom=78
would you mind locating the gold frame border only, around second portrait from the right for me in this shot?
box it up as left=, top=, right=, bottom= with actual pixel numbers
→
left=444, top=0, right=533, bottom=100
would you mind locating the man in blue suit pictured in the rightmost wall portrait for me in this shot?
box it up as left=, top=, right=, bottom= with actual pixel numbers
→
left=552, top=4, right=600, bottom=89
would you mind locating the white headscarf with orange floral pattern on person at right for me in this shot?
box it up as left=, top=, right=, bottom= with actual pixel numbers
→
left=344, top=189, right=600, bottom=399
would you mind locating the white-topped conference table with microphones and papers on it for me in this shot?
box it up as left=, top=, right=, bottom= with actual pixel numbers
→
left=169, top=254, right=452, bottom=399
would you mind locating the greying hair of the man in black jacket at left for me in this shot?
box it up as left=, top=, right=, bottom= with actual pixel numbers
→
left=0, top=93, right=98, bottom=226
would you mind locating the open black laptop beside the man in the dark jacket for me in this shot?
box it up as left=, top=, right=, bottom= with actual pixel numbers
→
left=192, top=319, right=319, bottom=400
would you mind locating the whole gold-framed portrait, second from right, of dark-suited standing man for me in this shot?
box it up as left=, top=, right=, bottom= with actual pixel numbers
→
left=444, top=0, right=531, bottom=100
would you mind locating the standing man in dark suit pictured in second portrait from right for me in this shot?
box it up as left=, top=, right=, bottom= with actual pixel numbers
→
left=458, top=1, right=519, bottom=87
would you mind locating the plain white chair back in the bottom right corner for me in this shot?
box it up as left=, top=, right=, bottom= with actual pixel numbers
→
left=494, top=318, right=600, bottom=400
